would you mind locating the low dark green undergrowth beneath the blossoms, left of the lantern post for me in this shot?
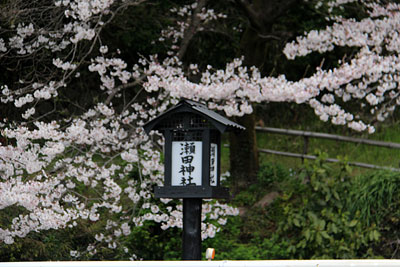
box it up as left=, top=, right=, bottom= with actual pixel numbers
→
left=0, top=211, right=182, bottom=261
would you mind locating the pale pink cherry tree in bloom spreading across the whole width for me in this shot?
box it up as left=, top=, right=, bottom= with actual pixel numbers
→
left=0, top=0, right=400, bottom=259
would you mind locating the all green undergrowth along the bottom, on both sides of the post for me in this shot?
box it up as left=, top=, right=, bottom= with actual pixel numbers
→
left=4, top=157, right=400, bottom=261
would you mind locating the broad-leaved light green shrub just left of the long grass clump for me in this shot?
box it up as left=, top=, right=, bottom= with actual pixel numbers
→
left=270, top=155, right=380, bottom=259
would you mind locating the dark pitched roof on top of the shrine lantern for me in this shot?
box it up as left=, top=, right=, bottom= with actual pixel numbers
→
left=143, top=99, right=246, bottom=133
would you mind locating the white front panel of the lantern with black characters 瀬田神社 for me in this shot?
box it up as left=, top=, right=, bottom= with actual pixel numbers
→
left=171, top=141, right=202, bottom=186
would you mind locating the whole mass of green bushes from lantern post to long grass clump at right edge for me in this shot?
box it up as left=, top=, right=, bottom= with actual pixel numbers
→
left=212, top=153, right=383, bottom=259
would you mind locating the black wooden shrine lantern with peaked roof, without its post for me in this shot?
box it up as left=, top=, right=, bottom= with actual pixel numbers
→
left=144, top=99, right=245, bottom=198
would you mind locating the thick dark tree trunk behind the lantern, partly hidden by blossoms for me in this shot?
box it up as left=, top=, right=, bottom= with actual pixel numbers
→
left=229, top=0, right=300, bottom=191
